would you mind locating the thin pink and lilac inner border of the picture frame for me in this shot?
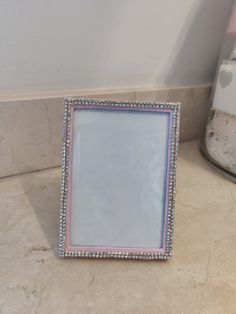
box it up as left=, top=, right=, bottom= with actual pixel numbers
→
left=65, top=104, right=173, bottom=254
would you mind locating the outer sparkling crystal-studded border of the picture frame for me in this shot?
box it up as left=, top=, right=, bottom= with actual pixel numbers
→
left=59, top=99, right=180, bottom=260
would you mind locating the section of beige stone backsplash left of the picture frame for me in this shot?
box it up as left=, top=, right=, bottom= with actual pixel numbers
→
left=0, top=98, right=63, bottom=177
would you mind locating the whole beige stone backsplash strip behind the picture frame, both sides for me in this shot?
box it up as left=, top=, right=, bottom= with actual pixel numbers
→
left=0, top=86, right=210, bottom=178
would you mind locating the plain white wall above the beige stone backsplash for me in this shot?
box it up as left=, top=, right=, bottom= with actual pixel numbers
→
left=0, top=0, right=232, bottom=96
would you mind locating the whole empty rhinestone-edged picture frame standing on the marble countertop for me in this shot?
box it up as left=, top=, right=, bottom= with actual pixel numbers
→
left=59, top=98, right=180, bottom=260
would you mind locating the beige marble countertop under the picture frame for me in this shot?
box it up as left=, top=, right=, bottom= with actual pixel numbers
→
left=0, top=142, right=236, bottom=314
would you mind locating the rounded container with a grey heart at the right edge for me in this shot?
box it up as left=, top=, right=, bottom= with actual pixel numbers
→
left=201, top=6, right=236, bottom=183
